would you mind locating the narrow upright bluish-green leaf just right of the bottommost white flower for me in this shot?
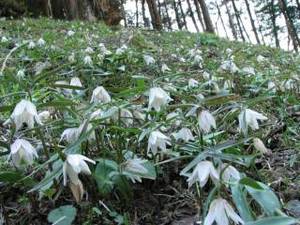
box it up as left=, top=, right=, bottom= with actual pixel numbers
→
left=230, top=183, right=253, bottom=222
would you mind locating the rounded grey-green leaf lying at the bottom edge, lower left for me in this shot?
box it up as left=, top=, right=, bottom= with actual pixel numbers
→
left=48, top=205, right=76, bottom=225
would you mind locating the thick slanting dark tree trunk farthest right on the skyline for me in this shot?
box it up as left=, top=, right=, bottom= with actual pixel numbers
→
left=278, top=0, right=300, bottom=52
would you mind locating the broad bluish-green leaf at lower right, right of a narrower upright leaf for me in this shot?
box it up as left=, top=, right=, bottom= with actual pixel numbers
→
left=245, top=182, right=281, bottom=216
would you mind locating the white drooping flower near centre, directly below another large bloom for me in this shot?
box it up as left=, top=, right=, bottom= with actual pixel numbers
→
left=148, top=131, right=171, bottom=155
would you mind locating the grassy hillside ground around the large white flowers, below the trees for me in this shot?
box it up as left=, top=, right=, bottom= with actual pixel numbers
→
left=0, top=19, right=300, bottom=224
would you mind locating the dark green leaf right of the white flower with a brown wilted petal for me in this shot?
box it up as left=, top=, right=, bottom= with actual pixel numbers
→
left=94, top=159, right=118, bottom=196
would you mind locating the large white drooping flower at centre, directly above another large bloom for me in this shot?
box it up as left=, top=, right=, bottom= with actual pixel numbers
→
left=149, top=87, right=172, bottom=112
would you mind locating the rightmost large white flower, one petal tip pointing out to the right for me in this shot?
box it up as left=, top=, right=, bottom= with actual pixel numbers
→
left=239, top=109, right=268, bottom=135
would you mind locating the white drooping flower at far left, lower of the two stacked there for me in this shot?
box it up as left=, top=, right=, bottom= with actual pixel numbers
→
left=10, top=139, right=38, bottom=167
